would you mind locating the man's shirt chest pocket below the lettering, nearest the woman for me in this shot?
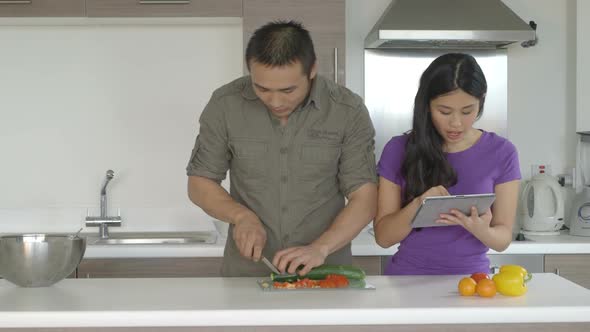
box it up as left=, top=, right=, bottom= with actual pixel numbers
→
left=296, top=144, right=342, bottom=181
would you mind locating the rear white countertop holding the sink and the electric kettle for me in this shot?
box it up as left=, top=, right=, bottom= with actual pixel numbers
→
left=84, top=231, right=590, bottom=258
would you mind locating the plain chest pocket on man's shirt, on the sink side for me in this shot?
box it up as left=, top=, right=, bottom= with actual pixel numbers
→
left=229, top=139, right=268, bottom=179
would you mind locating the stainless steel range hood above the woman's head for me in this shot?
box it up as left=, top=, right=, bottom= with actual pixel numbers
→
left=365, top=0, right=536, bottom=49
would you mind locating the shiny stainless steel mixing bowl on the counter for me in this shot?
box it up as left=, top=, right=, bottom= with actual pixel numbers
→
left=0, top=234, right=86, bottom=287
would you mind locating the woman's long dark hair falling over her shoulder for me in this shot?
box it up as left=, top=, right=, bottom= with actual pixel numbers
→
left=401, top=53, right=487, bottom=205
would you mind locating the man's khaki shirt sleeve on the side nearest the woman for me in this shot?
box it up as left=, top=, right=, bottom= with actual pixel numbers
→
left=338, top=102, right=377, bottom=196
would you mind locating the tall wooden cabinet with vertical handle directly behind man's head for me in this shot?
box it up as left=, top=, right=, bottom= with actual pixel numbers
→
left=243, top=0, right=346, bottom=84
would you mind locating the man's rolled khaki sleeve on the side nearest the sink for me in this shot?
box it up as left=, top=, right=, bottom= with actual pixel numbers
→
left=186, top=96, right=230, bottom=182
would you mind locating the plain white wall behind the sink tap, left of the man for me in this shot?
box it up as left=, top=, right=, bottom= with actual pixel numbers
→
left=0, top=19, right=242, bottom=233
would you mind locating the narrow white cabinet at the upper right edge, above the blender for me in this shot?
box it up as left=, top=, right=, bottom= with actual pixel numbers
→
left=576, top=0, right=590, bottom=133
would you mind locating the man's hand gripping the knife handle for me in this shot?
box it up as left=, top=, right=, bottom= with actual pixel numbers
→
left=232, top=215, right=266, bottom=262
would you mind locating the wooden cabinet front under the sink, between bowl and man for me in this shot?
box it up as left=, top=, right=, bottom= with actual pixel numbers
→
left=77, top=257, right=222, bottom=278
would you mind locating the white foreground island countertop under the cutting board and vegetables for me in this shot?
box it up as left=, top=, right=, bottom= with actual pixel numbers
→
left=0, top=274, right=590, bottom=328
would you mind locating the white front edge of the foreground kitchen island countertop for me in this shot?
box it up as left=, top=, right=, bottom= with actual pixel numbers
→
left=0, top=306, right=590, bottom=328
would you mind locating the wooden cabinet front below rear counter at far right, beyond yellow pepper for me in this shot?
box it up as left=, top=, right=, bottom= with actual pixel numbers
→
left=545, top=254, right=590, bottom=289
